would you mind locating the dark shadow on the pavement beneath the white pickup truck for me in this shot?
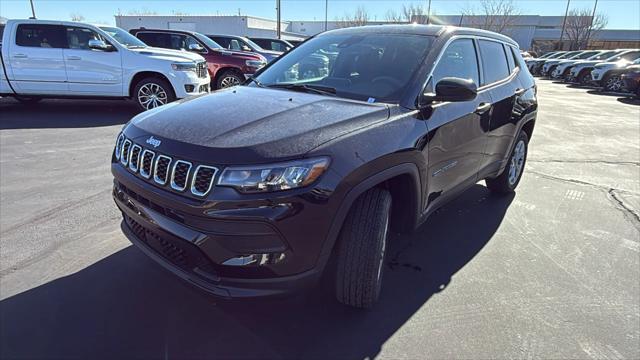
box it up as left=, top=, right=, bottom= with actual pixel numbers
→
left=0, top=98, right=139, bottom=130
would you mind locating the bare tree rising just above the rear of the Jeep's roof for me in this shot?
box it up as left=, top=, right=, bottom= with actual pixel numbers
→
left=462, top=0, right=521, bottom=34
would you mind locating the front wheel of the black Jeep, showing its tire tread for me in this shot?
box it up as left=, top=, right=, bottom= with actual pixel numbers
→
left=336, top=188, right=391, bottom=308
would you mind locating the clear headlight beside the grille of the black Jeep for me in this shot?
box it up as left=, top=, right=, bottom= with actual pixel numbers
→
left=218, top=157, right=329, bottom=193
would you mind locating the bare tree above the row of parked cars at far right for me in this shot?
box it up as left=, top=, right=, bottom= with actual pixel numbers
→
left=565, top=8, right=608, bottom=50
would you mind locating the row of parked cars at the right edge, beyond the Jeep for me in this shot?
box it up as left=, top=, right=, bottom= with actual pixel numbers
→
left=526, top=49, right=640, bottom=97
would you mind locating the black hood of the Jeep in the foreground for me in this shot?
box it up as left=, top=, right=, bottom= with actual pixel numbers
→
left=125, top=86, right=389, bottom=164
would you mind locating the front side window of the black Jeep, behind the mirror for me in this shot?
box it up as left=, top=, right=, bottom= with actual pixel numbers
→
left=433, top=39, right=480, bottom=85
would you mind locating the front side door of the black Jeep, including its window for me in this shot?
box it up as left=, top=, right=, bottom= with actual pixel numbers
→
left=425, top=39, right=492, bottom=211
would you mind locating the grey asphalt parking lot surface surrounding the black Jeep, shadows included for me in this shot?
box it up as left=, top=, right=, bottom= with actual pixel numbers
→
left=0, top=80, right=640, bottom=359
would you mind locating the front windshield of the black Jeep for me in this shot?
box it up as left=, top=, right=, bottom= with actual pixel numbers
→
left=251, top=34, right=433, bottom=103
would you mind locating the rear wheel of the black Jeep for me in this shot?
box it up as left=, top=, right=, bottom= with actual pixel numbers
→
left=485, top=131, right=529, bottom=194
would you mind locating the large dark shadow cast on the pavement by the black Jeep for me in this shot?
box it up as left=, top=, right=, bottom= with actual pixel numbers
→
left=0, top=185, right=513, bottom=359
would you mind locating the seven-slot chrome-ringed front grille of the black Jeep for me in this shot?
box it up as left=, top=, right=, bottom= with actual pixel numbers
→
left=116, top=136, right=218, bottom=197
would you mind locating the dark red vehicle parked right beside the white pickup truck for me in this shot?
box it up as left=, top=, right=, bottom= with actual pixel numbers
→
left=129, top=28, right=267, bottom=89
